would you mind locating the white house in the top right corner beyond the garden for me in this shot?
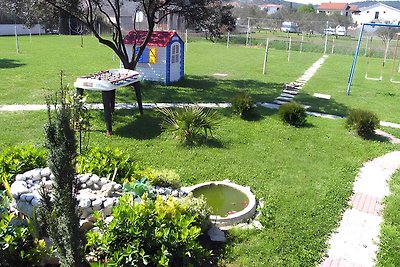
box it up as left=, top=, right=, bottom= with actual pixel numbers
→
left=353, top=3, right=400, bottom=25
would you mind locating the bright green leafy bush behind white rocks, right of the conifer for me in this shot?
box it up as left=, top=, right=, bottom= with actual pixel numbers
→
left=76, top=147, right=139, bottom=182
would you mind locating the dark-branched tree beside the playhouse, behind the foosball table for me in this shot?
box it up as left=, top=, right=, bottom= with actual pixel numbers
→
left=36, top=0, right=234, bottom=70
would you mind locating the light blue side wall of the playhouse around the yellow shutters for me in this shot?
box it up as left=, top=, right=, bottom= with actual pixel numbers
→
left=126, top=45, right=166, bottom=83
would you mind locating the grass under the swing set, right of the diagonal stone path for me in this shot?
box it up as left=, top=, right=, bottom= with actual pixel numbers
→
left=296, top=55, right=400, bottom=123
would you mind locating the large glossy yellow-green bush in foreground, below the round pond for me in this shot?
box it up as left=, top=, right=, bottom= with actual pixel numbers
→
left=87, top=194, right=210, bottom=266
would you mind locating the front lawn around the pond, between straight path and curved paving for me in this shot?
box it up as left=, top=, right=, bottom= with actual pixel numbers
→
left=0, top=109, right=394, bottom=266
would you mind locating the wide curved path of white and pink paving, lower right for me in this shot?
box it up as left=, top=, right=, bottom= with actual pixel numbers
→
left=319, top=151, right=400, bottom=267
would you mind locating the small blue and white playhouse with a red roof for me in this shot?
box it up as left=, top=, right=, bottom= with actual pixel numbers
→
left=124, top=31, right=185, bottom=84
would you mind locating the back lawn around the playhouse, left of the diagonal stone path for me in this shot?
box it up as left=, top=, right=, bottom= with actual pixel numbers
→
left=0, top=36, right=320, bottom=104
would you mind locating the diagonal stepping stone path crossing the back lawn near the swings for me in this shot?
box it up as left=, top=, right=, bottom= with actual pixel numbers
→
left=273, top=55, right=328, bottom=105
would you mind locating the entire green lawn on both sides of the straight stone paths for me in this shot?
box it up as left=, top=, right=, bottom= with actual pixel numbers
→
left=0, top=36, right=400, bottom=266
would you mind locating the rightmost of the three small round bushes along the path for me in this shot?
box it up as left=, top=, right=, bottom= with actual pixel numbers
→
left=346, top=109, right=379, bottom=138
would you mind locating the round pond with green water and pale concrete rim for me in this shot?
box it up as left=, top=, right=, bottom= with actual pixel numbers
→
left=184, top=181, right=256, bottom=225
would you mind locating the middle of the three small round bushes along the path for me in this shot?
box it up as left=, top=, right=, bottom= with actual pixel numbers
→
left=279, top=102, right=307, bottom=127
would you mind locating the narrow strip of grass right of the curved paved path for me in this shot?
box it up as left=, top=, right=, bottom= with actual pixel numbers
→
left=377, top=171, right=400, bottom=267
